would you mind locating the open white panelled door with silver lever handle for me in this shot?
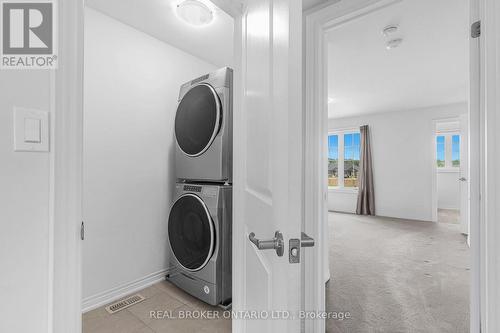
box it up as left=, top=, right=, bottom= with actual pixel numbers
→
left=233, top=0, right=307, bottom=333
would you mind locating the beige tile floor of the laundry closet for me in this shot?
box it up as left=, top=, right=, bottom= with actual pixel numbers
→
left=82, top=281, right=231, bottom=333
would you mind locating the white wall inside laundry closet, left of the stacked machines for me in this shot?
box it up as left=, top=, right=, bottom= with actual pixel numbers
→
left=83, top=8, right=215, bottom=306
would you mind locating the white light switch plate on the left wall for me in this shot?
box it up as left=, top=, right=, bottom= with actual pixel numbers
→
left=14, top=107, right=49, bottom=152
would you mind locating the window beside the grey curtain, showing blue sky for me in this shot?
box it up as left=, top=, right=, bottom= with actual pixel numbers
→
left=328, top=130, right=361, bottom=188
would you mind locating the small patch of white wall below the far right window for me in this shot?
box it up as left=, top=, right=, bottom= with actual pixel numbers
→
left=437, top=170, right=460, bottom=209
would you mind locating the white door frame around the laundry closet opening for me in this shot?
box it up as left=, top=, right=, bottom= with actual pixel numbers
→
left=47, top=0, right=246, bottom=333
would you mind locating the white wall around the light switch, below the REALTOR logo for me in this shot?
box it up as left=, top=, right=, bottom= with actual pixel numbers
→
left=0, top=70, right=51, bottom=333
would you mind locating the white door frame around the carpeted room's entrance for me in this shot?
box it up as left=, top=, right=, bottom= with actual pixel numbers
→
left=303, top=0, right=494, bottom=333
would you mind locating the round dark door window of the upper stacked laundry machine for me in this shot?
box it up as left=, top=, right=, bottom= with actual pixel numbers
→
left=175, top=83, right=221, bottom=156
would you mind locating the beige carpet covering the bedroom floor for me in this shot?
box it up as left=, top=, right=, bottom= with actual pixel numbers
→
left=327, top=213, right=470, bottom=333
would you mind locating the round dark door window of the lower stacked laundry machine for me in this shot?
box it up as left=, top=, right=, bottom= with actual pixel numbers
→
left=168, top=194, right=215, bottom=271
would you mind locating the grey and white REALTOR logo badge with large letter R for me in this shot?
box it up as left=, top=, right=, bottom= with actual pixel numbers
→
left=0, top=0, right=57, bottom=69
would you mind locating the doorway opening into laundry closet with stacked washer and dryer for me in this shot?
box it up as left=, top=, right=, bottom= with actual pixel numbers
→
left=82, top=0, right=234, bottom=333
